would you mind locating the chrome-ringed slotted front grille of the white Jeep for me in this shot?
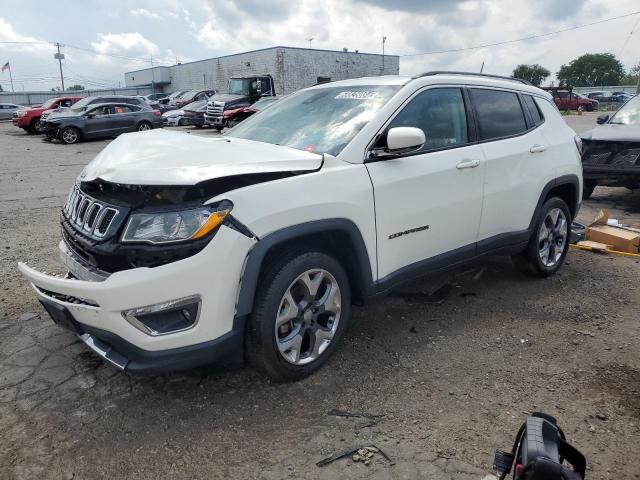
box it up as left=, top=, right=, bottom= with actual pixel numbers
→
left=62, top=185, right=120, bottom=239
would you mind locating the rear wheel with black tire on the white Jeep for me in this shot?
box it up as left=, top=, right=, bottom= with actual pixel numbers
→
left=511, top=197, right=571, bottom=278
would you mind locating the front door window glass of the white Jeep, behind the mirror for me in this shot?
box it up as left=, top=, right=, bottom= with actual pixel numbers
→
left=388, top=88, right=469, bottom=152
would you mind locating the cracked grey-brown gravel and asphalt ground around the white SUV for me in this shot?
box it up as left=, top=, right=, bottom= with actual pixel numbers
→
left=0, top=115, right=640, bottom=480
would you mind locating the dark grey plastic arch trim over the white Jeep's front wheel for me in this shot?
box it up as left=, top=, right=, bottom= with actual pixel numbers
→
left=236, top=218, right=373, bottom=317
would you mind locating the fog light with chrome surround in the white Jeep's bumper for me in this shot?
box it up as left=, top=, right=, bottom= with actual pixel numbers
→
left=122, top=295, right=202, bottom=337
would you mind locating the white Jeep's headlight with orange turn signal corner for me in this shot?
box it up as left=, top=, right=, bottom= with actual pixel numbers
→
left=122, top=202, right=232, bottom=243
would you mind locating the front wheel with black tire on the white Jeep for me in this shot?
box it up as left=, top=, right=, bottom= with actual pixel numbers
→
left=246, top=251, right=351, bottom=382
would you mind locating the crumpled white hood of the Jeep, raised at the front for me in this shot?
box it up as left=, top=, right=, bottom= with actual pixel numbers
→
left=80, top=129, right=322, bottom=186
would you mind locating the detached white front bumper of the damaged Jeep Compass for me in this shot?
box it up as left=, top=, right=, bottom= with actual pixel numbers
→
left=18, top=227, right=255, bottom=371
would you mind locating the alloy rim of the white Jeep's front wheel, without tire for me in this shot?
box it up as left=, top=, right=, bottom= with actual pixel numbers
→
left=275, top=269, right=341, bottom=365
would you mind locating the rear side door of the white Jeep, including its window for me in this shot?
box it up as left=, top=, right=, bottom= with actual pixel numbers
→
left=469, top=88, right=548, bottom=253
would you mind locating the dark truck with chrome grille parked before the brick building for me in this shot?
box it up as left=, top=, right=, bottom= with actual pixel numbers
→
left=204, top=75, right=276, bottom=131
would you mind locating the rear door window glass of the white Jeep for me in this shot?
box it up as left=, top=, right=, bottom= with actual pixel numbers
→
left=471, top=88, right=527, bottom=140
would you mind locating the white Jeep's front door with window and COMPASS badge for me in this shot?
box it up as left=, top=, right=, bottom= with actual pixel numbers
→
left=366, top=87, right=484, bottom=281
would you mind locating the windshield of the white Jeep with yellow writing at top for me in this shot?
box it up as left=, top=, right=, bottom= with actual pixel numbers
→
left=228, top=85, right=400, bottom=155
